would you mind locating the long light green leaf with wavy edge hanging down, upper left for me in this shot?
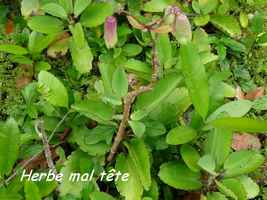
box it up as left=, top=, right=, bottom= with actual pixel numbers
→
left=70, top=23, right=94, bottom=74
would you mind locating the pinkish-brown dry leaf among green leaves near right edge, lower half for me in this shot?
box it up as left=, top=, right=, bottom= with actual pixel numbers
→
left=232, top=133, right=261, bottom=151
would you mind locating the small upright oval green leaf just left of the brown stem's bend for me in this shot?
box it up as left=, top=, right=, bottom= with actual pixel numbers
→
left=112, top=67, right=128, bottom=97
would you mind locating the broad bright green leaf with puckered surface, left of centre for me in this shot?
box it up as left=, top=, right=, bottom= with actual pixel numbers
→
left=38, top=71, right=69, bottom=107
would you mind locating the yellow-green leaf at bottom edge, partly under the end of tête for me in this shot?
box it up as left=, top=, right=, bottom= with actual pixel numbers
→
left=115, top=154, right=143, bottom=200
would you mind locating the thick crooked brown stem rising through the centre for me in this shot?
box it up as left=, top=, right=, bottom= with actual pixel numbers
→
left=107, top=39, right=159, bottom=162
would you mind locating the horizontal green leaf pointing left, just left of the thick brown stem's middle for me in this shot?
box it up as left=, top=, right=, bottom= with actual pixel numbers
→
left=72, top=100, right=113, bottom=121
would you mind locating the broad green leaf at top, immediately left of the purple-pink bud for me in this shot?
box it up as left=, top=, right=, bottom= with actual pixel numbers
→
left=80, top=2, right=113, bottom=28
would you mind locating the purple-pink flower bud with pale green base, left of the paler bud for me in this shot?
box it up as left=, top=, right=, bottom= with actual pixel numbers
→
left=104, top=16, right=118, bottom=48
